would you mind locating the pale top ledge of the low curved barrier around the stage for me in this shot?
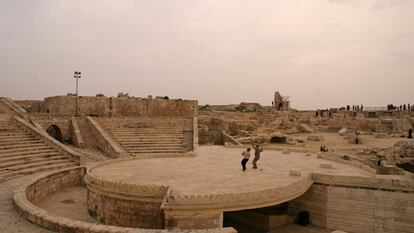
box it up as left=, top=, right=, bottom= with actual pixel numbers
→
left=13, top=167, right=236, bottom=233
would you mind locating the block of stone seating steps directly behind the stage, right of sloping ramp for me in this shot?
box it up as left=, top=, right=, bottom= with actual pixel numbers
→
left=99, top=118, right=184, bottom=156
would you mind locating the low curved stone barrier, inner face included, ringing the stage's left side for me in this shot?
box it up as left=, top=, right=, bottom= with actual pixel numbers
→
left=13, top=167, right=236, bottom=233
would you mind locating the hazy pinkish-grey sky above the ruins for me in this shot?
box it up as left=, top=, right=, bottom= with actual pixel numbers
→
left=0, top=0, right=414, bottom=109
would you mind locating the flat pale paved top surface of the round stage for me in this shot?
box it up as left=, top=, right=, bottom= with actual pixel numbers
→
left=92, top=146, right=370, bottom=195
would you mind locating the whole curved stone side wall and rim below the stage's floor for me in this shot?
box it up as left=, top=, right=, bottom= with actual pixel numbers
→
left=85, top=159, right=313, bottom=229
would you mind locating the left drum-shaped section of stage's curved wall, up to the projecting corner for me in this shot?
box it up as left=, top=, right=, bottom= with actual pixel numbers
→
left=85, top=163, right=168, bottom=229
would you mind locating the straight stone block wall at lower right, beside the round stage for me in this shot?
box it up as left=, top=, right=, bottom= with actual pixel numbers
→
left=289, top=176, right=414, bottom=233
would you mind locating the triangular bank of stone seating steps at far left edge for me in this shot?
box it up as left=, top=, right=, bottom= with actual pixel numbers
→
left=0, top=115, right=77, bottom=183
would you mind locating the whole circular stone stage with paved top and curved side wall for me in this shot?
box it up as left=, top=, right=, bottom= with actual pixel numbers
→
left=85, top=146, right=372, bottom=229
